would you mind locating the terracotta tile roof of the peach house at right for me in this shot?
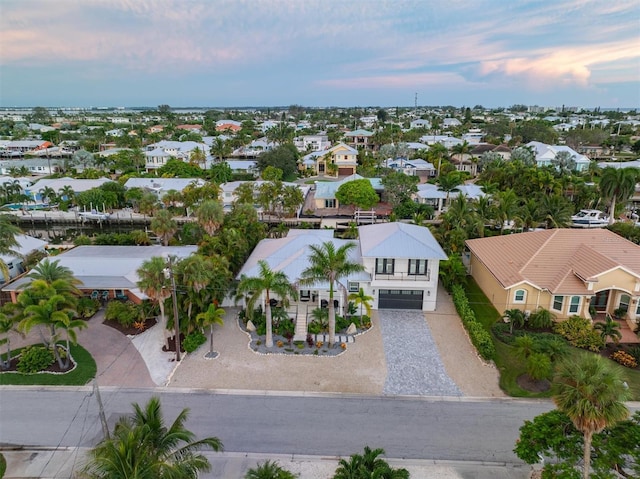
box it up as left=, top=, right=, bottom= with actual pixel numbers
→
left=467, top=229, right=640, bottom=294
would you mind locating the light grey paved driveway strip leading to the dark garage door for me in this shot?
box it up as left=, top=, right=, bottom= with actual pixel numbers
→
left=378, top=310, right=462, bottom=396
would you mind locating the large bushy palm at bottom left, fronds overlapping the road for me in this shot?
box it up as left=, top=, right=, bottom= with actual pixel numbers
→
left=83, top=397, right=223, bottom=479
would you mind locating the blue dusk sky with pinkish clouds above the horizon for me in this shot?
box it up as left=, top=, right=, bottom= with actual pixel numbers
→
left=0, top=0, right=640, bottom=108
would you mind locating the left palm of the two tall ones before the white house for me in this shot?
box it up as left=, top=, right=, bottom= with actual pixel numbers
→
left=237, top=260, right=298, bottom=348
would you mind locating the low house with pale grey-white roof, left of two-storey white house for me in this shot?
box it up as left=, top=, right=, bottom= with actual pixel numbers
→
left=1, top=245, right=198, bottom=303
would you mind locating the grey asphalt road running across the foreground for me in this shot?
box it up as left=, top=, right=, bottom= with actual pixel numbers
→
left=0, top=387, right=553, bottom=463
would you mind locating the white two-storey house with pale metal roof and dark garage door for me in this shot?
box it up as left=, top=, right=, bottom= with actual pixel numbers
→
left=238, top=223, right=447, bottom=314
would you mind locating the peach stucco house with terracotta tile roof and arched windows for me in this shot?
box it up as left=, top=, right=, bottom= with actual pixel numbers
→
left=466, top=229, right=640, bottom=327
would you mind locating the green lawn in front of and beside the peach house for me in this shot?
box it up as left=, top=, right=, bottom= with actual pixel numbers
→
left=465, top=278, right=640, bottom=401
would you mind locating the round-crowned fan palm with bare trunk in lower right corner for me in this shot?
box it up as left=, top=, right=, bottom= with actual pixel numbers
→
left=553, top=354, right=629, bottom=479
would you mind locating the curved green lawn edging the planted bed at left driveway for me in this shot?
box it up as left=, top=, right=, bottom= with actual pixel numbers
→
left=0, top=345, right=97, bottom=386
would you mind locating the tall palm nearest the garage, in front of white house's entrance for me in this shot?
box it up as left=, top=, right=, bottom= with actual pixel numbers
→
left=300, top=241, right=364, bottom=347
